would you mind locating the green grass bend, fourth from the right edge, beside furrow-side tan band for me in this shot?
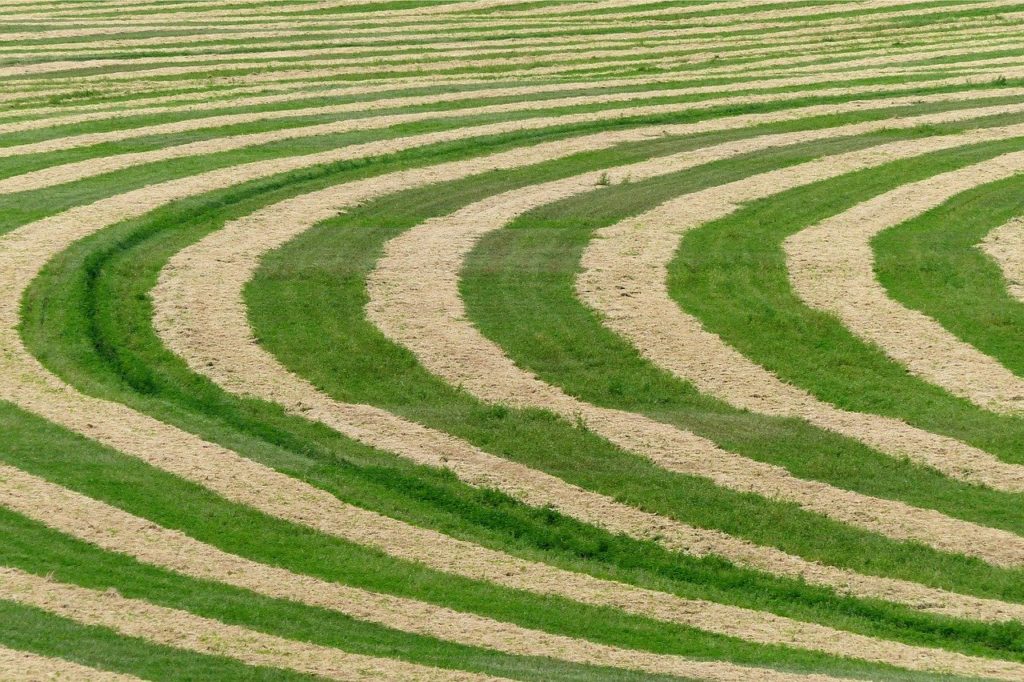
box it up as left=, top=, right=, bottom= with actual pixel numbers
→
left=241, top=107, right=1016, bottom=589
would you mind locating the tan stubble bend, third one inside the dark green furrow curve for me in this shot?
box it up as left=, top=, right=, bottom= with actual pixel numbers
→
left=577, top=146, right=1024, bottom=493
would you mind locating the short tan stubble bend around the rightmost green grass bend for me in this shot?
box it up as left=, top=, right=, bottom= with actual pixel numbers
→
left=785, top=153, right=1024, bottom=414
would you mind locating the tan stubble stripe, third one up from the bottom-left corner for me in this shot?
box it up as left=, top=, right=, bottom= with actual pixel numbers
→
left=0, top=467, right=864, bottom=680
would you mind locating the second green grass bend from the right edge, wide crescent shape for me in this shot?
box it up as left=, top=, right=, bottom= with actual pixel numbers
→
left=670, top=129, right=1024, bottom=462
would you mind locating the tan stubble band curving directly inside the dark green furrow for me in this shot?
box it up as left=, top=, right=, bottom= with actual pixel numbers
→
left=153, top=103, right=1020, bottom=620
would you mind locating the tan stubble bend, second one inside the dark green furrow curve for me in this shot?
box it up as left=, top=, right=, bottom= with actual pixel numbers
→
left=368, top=118, right=1024, bottom=566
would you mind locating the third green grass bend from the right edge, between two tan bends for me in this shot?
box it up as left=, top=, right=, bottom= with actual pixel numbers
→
left=456, top=112, right=1022, bottom=520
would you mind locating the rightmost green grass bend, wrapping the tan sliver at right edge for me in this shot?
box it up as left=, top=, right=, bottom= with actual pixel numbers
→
left=872, top=169, right=1024, bottom=374
